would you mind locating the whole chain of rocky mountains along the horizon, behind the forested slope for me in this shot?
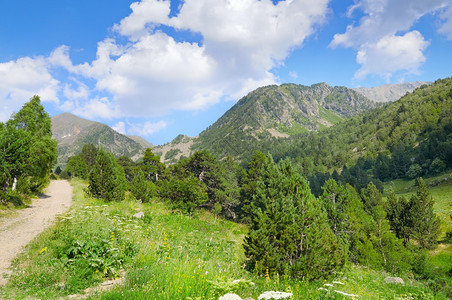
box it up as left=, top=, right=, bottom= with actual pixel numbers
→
left=52, top=82, right=425, bottom=167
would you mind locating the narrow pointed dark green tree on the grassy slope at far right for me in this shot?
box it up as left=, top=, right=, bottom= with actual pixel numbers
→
left=409, top=178, right=440, bottom=248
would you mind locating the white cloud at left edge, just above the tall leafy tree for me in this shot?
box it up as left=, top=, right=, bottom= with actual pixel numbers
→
left=0, top=57, right=60, bottom=121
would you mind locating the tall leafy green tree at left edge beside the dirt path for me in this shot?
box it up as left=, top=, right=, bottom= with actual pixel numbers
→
left=0, top=96, right=57, bottom=201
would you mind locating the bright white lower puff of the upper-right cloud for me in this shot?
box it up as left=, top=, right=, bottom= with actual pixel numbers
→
left=355, top=31, right=429, bottom=81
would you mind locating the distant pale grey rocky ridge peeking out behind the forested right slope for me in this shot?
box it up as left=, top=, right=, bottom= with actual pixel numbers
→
left=353, top=81, right=431, bottom=102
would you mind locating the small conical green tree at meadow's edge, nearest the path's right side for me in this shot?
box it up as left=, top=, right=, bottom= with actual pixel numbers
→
left=88, top=149, right=126, bottom=201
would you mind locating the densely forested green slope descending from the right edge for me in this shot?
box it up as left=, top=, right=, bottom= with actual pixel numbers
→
left=272, top=78, right=452, bottom=176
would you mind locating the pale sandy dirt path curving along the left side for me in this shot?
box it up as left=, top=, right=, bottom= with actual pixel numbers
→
left=0, top=180, right=72, bottom=285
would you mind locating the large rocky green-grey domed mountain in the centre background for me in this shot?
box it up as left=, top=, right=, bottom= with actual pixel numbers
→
left=192, top=83, right=377, bottom=160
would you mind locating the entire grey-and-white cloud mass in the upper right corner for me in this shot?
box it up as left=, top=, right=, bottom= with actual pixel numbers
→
left=330, top=0, right=450, bottom=79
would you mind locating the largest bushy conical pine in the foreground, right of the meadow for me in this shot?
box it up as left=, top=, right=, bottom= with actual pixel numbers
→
left=244, top=156, right=345, bottom=280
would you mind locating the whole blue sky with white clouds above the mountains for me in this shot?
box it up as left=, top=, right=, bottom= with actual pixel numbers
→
left=0, top=0, right=452, bottom=145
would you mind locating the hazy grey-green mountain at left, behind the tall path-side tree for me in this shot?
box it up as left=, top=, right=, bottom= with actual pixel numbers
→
left=52, top=113, right=147, bottom=167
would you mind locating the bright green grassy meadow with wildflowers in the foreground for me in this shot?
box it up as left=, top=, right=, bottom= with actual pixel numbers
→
left=0, top=180, right=447, bottom=299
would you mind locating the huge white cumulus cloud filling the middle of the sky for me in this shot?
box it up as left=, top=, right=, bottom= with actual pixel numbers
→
left=72, top=0, right=328, bottom=116
